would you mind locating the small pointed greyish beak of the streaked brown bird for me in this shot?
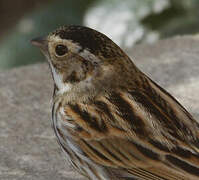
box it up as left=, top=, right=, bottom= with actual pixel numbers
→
left=31, top=37, right=48, bottom=53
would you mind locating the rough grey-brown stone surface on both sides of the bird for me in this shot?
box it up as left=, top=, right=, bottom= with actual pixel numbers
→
left=0, top=36, right=199, bottom=180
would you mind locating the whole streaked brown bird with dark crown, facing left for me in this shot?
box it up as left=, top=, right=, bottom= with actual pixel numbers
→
left=31, top=25, right=199, bottom=180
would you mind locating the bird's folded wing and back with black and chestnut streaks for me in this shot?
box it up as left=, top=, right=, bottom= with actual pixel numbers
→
left=65, top=76, right=199, bottom=180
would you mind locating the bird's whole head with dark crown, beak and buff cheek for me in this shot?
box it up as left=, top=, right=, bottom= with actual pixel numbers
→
left=32, top=26, right=138, bottom=97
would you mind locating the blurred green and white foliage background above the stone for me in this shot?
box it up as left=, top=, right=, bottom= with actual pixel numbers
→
left=0, top=0, right=199, bottom=70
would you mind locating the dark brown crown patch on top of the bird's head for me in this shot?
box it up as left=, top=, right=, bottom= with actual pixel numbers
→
left=52, top=25, right=123, bottom=58
